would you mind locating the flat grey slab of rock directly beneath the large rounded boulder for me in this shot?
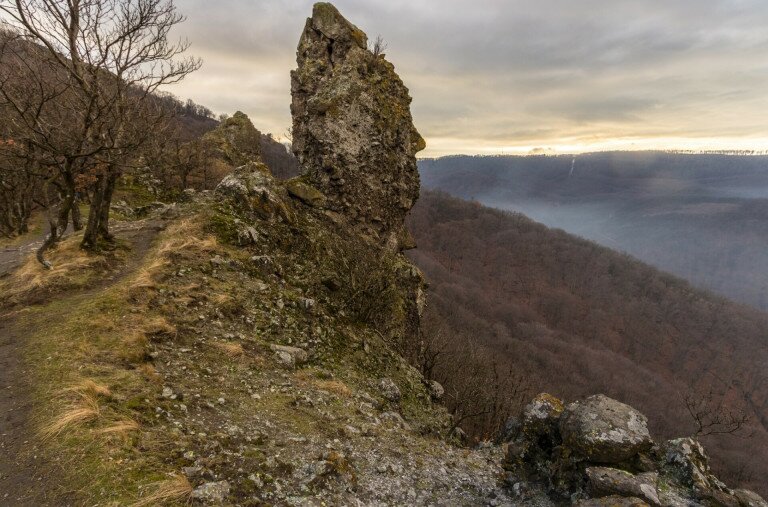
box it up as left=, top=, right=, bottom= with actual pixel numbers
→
left=586, top=467, right=661, bottom=506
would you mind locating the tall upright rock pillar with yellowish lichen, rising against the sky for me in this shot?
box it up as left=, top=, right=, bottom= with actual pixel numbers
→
left=291, top=3, right=425, bottom=250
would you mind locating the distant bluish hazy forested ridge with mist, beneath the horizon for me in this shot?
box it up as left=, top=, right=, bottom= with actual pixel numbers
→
left=420, top=152, right=768, bottom=309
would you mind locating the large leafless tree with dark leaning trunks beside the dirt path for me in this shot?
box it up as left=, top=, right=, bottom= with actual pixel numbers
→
left=0, top=0, right=201, bottom=262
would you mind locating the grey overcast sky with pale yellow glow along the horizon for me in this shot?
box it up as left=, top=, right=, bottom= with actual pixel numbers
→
left=170, top=0, right=768, bottom=156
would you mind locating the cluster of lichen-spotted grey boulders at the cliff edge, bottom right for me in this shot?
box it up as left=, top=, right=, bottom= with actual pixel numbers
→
left=505, top=394, right=768, bottom=507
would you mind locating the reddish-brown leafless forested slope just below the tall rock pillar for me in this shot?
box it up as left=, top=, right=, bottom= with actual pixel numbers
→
left=410, top=192, right=768, bottom=491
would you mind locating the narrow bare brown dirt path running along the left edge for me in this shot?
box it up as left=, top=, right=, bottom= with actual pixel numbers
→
left=0, top=221, right=164, bottom=507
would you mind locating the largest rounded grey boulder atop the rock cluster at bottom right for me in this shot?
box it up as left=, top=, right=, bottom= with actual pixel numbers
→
left=560, top=394, right=653, bottom=463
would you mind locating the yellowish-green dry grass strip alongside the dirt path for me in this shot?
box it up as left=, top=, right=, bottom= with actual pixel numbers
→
left=12, top=220, right=218, bottom=505
